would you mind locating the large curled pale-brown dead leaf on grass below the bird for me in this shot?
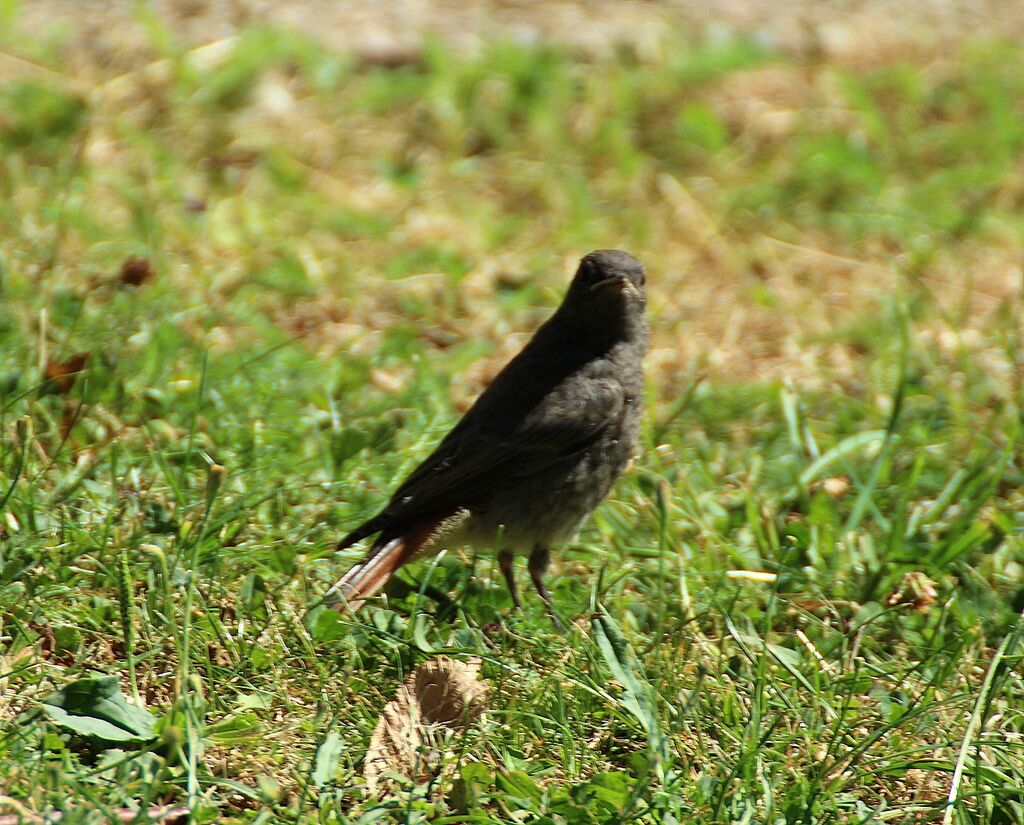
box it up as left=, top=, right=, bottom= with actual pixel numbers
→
left=362, top=656, right=487, bottom=795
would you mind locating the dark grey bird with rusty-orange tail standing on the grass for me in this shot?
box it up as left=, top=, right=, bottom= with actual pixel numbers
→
left=325, top=250, right=650, bottom=628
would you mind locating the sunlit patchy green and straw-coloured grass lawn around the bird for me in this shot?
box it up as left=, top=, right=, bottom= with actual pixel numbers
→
left=0, top=12, right=1024, bottom=825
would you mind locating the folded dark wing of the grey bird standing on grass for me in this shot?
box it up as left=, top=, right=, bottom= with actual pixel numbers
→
left=339, top=379, right=625, bottom=548
